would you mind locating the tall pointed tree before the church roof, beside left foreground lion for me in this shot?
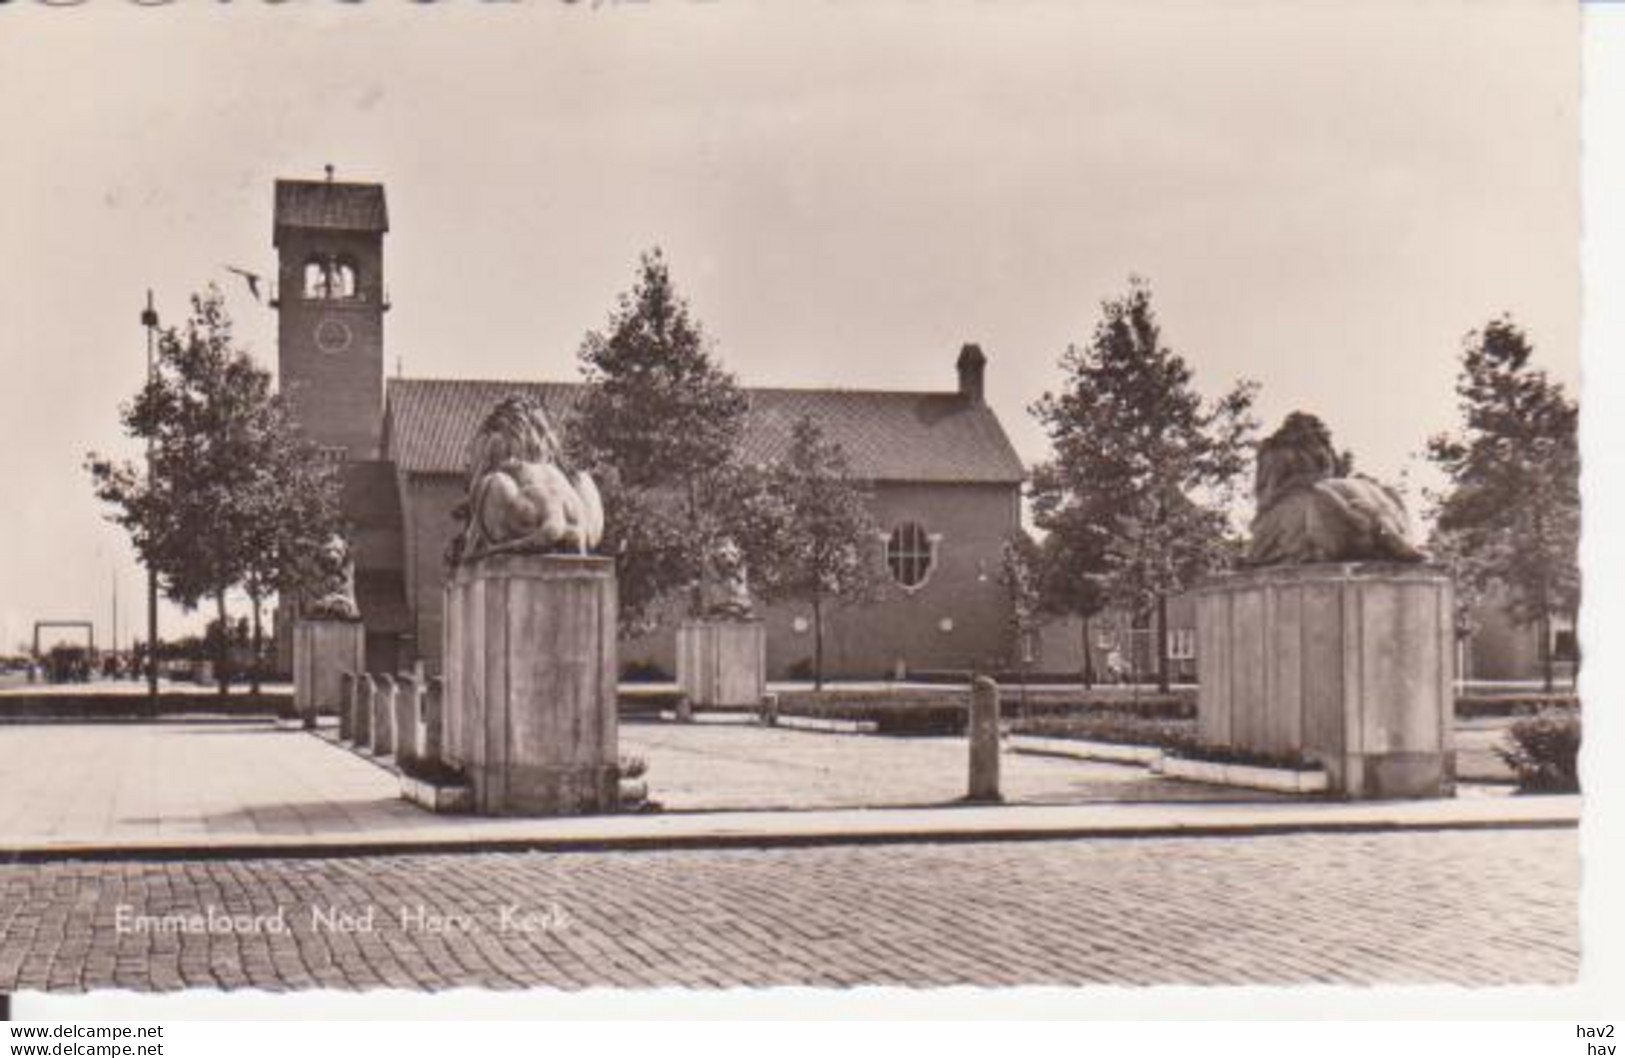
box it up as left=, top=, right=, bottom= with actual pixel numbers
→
left=569, top=249, right=746, bottom=634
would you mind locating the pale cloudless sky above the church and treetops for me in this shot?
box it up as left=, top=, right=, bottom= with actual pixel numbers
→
left=0, top=0, right=1580, bottom=652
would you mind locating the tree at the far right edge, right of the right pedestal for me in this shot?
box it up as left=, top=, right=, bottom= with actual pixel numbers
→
left=1427, top=315, right=1580, bottom=691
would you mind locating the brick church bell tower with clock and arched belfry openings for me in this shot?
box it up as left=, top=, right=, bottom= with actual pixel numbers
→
left=271, top=166, right=390, bottom=460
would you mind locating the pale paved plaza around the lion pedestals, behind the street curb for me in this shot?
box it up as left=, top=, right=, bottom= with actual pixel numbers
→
left=0, top=722, right=1268, bottom=843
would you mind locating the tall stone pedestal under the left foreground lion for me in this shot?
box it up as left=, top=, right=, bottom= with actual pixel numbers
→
left=444, top=554, right=619, bottom=816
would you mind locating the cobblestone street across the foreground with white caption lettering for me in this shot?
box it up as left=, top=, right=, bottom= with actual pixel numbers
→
left=0, top=829, right=1580, bottom=991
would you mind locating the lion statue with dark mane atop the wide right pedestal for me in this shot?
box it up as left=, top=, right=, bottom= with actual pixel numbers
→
left=1246, top=411, right=1424, bottom=566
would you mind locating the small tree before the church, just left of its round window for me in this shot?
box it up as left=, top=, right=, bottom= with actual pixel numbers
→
left=743, top=416, right=884, bottom=691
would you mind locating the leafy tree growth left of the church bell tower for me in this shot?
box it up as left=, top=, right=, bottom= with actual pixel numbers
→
left=86, top=286, right=340, bottom=694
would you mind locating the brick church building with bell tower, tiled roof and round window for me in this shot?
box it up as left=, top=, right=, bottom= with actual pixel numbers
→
left=273, top=176, right=1022, bottom=679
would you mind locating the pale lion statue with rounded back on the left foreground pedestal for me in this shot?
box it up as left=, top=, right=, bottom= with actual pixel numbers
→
left=453, top=395, right=605, bottom=561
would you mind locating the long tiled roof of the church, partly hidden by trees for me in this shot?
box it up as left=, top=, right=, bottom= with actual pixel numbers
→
left=384, top=379, right=1022, bottom=483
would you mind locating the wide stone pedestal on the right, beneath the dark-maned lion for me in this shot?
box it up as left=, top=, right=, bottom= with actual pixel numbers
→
left=1196, top=562, right=1454, bottom=798
